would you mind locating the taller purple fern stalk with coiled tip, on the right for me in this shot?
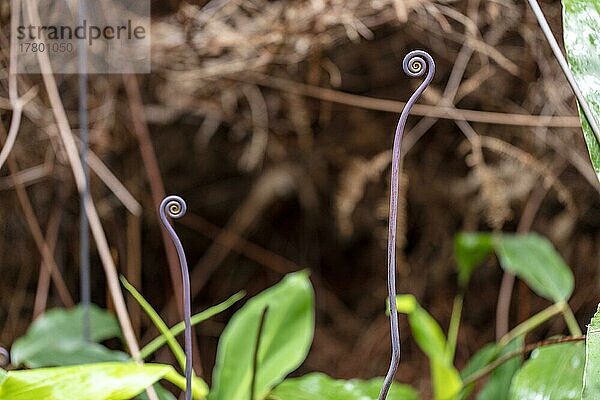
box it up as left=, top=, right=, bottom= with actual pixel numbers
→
left=379, top=50, right=435, bottom=400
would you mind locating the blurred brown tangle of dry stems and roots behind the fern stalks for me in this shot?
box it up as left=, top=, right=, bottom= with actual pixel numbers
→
left=0, top=0, right=600, bottom=393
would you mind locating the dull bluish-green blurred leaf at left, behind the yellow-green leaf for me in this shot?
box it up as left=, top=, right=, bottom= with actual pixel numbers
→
left=11, top=304, right=129, bottom=368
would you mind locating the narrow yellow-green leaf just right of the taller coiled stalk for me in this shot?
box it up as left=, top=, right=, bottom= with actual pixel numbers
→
left=396, top=295, right=462, bottom=400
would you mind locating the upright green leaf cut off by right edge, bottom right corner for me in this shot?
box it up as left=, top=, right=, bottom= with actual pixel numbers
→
left=581, top=305, right=600, bottom=400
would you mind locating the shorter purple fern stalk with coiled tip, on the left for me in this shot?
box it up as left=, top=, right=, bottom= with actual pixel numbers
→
left=159, top=196, right=193, bottom=400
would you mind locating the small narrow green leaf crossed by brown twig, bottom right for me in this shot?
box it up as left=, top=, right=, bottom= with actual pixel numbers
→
left=477, top=337, right=523, bottom=400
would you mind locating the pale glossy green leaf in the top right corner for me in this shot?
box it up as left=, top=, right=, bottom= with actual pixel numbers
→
left=563, top=0, right=600, bottom=180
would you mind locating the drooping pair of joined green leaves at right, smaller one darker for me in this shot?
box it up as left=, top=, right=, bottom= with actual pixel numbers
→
left=455, top=233, right=574, bottom=302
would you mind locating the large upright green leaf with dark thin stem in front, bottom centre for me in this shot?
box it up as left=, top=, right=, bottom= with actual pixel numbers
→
left=209, top=271, right=315, bottom=400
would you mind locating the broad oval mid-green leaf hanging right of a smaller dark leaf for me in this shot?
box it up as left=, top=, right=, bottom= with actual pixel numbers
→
left=494, top=234, right=574, bottom=303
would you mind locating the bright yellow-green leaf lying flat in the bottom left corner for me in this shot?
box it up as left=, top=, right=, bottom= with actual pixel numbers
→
left=0, top=363, right=174, bottom=400
